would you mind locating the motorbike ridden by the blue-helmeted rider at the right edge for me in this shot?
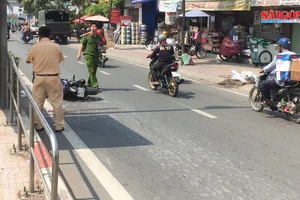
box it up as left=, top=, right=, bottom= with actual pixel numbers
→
left=249, top=73, right=300, bottom=123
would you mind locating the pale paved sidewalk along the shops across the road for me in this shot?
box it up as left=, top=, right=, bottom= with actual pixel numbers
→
left=68, top=42, right=260, bottom=93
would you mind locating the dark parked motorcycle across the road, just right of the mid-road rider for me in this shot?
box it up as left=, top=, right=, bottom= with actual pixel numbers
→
left=175, top=40, right=207, bottom=59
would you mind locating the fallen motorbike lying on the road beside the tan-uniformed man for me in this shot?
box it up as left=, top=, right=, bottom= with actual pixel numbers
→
left=61, top=75, right=99, bottom=99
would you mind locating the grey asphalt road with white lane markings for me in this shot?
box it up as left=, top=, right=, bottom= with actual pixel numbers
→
left=8, top=33, right=300, bottom=200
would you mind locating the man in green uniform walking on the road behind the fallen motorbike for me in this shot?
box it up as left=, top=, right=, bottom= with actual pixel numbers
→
left=77, top=22, right=103, bottom=88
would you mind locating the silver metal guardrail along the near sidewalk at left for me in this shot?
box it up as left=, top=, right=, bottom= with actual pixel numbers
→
left=6, top=53, right=59, bottom=200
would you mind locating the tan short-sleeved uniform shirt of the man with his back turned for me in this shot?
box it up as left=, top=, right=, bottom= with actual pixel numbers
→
left=26, top=38, right=64, bottom=74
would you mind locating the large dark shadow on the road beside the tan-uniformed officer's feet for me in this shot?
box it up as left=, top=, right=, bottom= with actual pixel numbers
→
left=39, top=113, right=153, bottom=150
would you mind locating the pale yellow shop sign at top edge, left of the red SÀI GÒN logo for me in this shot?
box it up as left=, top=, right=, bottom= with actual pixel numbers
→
left=185, top=0, right=251, bottom=11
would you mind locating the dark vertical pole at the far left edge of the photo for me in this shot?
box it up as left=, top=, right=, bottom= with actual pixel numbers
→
left=0, top=0, right=7, bottom=108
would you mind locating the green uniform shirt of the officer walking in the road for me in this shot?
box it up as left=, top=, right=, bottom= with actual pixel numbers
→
left=81, top=34, right=102, bottom=57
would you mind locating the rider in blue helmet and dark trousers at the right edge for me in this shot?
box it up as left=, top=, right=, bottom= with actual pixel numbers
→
left=260, top=38, right=296, bottom=106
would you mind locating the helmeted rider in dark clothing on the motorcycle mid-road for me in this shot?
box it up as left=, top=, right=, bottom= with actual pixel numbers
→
left=150, top=34, right=174, bottom=85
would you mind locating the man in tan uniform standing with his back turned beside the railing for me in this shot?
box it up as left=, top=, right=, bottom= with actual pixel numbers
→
left=26, top=26, right=64, bottom=132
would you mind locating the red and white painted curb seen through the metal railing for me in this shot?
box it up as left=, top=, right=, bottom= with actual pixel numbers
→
left=19, top=69, right=73, bottom=200
